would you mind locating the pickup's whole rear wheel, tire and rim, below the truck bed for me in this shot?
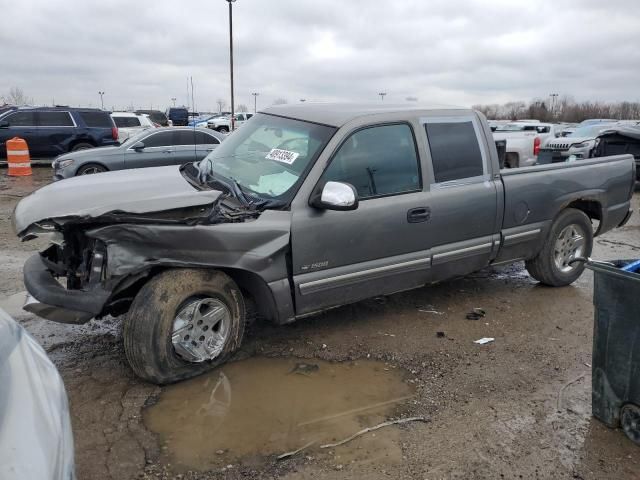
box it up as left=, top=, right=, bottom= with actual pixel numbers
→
left=525, top=208, right=593, bottom=287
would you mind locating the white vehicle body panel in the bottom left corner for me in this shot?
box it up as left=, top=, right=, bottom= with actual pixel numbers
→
left=0, top=309, right=76, bottom=480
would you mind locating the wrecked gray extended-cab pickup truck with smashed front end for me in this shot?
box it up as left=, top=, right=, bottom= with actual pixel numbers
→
left=14, top=105, right=635, bottom=383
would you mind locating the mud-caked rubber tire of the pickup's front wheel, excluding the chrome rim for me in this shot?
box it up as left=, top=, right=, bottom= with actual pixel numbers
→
left=123, top=269, right=245, bottom=384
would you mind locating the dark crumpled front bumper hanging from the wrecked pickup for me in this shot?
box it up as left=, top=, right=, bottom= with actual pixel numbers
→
left=23, top=254, right=110, bottom=324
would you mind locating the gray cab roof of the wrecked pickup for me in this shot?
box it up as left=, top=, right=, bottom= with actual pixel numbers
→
left=260, top=102, right=473, bottom=127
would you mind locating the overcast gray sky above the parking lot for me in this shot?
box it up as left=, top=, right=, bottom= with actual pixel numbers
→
left=0, top=0, right=640, bottom=111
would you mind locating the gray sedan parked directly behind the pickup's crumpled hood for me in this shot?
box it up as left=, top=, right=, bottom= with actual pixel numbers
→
left=53, top=127, right=225, bottom=180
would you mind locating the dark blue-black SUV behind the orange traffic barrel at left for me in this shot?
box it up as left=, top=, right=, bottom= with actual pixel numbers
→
left=0, top=107, right=118, bottom=158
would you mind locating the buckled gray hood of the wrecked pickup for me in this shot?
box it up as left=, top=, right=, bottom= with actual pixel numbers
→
left=13, top=166, right=221, bottom=234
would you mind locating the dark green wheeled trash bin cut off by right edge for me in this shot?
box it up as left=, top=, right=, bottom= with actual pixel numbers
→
left=587, top=260, right=640, bottom=445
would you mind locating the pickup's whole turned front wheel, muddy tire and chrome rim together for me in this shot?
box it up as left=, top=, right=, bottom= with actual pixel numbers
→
left=123, top=269, right=246, bottom=384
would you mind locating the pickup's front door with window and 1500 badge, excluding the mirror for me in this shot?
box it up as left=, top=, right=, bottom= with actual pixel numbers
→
left=291, top=123, right=431, bottom=315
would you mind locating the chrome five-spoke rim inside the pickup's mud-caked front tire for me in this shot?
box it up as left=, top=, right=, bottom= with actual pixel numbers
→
left=171, top=297, right=231, bottom=363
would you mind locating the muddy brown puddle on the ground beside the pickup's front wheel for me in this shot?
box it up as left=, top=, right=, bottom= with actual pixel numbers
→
left=143, top=358, right=414, bottom=470
